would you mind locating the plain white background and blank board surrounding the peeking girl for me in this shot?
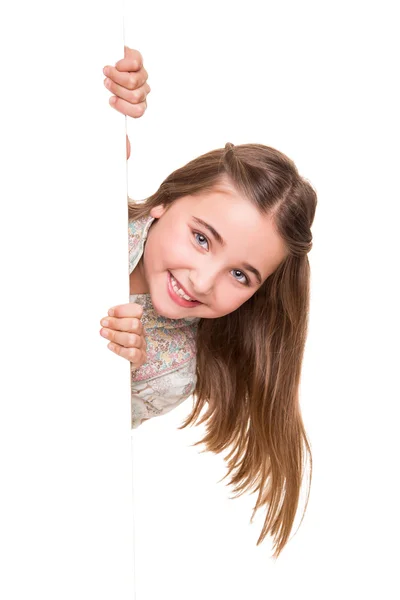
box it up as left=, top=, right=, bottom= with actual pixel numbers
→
left=0, top=0, right=400, bottom=600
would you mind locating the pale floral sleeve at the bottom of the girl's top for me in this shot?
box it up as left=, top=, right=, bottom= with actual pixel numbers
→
left=131, top=360, right=196, bottom=429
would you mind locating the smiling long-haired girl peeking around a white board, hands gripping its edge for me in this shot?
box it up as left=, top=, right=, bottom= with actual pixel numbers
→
left=101, top=49, right=317, bottom=558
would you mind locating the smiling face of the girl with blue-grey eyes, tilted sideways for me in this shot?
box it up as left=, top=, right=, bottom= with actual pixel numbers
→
left=138, top=178, right=287, bottom=319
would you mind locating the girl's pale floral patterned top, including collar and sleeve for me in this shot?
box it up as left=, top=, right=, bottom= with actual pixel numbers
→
left=128, top=216, right=200, bottom=429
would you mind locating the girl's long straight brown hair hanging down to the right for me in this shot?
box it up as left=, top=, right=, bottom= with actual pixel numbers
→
left=128, top=143, right=317, bottom=558
